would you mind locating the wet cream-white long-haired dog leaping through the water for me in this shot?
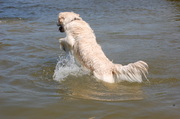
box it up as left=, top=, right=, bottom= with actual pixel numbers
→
left=57, top=12, right=148, bottom=83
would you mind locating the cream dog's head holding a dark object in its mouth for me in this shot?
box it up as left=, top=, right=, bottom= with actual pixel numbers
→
left=57, top=12, right=81, bottom=32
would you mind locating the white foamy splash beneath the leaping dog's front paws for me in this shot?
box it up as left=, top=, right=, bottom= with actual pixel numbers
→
left=53, top=53, right=81, bottom=81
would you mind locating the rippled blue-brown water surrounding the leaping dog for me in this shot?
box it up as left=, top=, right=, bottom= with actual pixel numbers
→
left=0, top=0, right=180, bottom=119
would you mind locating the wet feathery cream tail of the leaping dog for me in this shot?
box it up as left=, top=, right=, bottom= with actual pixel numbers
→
left=114, top=61, right=148, bottom=83
